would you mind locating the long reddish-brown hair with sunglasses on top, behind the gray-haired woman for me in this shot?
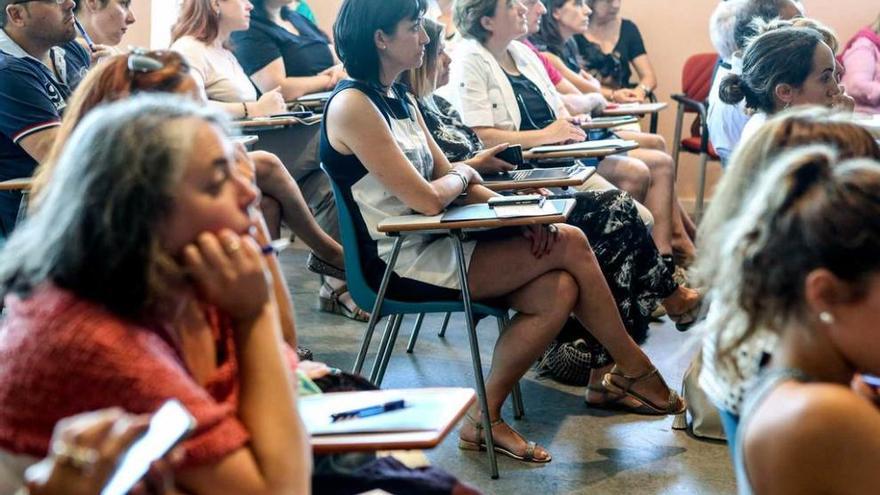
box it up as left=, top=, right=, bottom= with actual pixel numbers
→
left=31, top=50, right=190, bottom=202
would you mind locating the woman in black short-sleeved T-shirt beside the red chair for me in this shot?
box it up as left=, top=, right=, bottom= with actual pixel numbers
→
left=574, top=0, right=657, bottom=102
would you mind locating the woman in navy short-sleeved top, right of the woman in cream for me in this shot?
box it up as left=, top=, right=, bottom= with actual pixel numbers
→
left=232, top=0, right=345, bottom=101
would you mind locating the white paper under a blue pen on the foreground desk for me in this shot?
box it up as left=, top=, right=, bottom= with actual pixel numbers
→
left=298, top=390, right=461, bottom=436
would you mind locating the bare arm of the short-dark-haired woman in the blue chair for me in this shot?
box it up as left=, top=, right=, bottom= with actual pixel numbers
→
left=324, top=89, right=476, bottom=215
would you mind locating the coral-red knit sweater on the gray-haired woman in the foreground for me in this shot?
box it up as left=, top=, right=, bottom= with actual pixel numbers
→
left=0, top=284, right=296, bottom=466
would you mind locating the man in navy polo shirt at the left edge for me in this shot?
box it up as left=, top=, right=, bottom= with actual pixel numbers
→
left=0, top=0, right=90, bottom=234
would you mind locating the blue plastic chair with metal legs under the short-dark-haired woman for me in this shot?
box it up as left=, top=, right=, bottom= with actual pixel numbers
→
left=321, top=164, right=523, bottom=479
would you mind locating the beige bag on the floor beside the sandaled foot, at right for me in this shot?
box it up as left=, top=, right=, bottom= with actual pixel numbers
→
left=672, top=350, right=727, bottom=441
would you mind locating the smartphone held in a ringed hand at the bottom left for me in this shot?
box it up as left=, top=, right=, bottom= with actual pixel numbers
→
left=101, top=399, right=196, bottom=495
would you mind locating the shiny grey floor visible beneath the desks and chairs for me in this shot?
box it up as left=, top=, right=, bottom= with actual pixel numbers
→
left=281, top=249, right=736, bottom=495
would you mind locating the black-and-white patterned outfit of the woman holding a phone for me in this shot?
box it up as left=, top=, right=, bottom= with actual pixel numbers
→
left=418, top=95, right=678, bottom=367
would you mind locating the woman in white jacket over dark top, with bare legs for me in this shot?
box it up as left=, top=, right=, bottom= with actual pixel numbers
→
left=450, top=0, right=693, bottom=270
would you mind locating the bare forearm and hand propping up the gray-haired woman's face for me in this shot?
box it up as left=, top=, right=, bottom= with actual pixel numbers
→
left=177, top=231, right=311, bottom=495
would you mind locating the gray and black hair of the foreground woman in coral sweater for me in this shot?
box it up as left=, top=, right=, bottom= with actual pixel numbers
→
left=0, top=94, right=231, bottom=318
